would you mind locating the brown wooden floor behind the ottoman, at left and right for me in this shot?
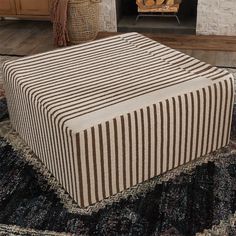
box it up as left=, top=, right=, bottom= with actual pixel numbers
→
left=0, top=20, right=236, bottom=67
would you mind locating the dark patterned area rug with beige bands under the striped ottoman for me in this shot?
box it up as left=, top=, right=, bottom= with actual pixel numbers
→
left=0, top=54, right=236, bottom=236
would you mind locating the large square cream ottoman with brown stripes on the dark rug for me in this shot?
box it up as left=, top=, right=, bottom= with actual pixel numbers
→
left=3, top=33, right=234, bottom=207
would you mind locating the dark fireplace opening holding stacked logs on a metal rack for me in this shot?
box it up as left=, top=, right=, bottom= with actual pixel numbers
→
left=116, top=0, right=197, bottom=34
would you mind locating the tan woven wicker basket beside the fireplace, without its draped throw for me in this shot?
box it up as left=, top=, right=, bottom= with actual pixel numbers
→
left=67, top=0, right=100, bottom=44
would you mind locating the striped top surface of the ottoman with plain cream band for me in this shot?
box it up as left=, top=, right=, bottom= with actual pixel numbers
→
left=3, top=33, right=230, bottom=131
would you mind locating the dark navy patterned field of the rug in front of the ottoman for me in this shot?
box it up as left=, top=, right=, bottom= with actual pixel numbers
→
left=0, top=135, right=236, bottom=236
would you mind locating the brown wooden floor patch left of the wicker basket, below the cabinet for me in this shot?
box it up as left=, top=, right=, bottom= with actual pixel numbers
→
left=0, top=20, right=54, bottom=55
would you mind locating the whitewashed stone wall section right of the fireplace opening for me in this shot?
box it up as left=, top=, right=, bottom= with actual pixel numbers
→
left=197, top=0, right=236, bottom=36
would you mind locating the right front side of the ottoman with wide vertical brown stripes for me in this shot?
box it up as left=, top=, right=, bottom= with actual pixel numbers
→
left=75, top=80, right=233, bottom=207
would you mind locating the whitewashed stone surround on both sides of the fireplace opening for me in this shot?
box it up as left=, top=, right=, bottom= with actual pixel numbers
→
left=100, top=0, right=236, bottom=36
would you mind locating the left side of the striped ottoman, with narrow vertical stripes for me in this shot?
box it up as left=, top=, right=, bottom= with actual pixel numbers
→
left=4, top=62, right=79, bottom=201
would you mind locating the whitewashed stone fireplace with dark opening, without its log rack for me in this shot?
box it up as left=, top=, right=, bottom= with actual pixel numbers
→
left=99, top=0, right=236, bottom=36
